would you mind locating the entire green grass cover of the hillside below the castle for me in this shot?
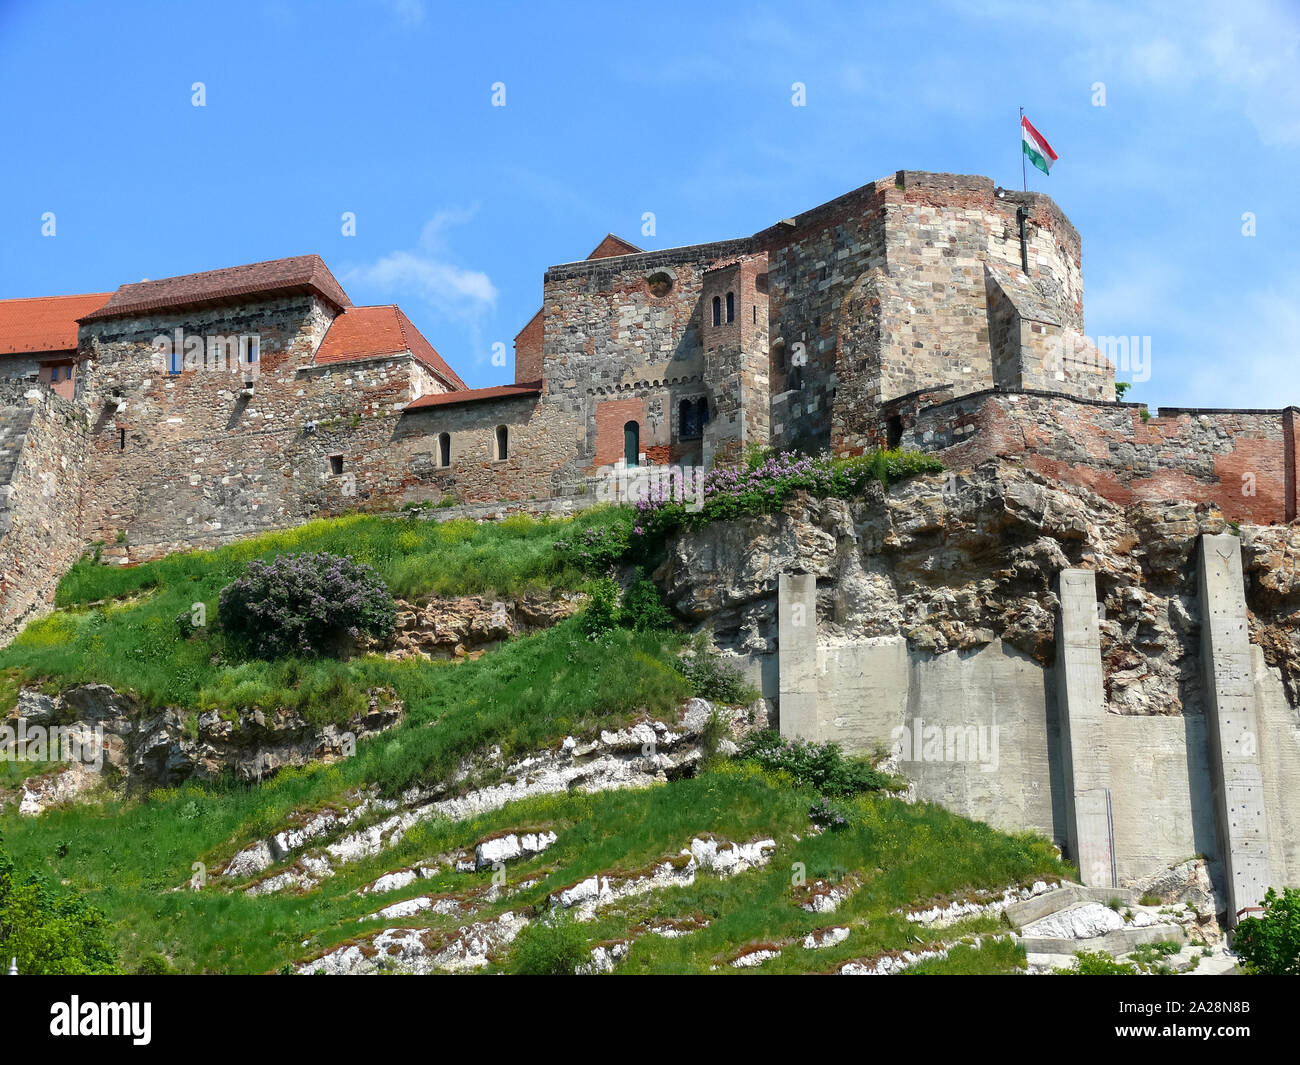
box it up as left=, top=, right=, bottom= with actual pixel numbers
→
left=0, top=465, right=1066, bottom=973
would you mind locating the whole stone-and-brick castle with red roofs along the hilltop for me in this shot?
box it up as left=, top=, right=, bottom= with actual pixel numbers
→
left=0, top=170, right=1296, bottom=633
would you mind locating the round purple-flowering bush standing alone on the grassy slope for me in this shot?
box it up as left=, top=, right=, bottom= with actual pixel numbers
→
left=218, top=551, right=397, bottom=658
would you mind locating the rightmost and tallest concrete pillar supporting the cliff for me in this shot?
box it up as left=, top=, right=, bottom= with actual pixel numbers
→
left=1200, top=534, right=1273, bottom=927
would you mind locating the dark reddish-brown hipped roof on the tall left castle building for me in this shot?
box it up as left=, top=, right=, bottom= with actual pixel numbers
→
left=82, top=255, right=352, bottom=321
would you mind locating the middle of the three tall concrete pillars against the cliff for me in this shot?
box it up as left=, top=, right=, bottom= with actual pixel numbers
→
left=1057, top=570, right=1117, bottom=887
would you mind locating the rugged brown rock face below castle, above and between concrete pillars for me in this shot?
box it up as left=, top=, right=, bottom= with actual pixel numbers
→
left=655, top=462, right=1300, bottom=715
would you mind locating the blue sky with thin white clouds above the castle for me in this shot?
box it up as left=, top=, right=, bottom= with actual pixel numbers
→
left=0, top=0, right=1300, bottom=407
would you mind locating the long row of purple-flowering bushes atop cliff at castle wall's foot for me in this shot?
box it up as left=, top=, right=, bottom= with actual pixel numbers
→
left=632, top=450, right=944, bottom=546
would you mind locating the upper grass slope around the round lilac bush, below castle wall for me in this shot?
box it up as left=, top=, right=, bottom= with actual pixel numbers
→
left=0, top=508, right=639, bottom=722
